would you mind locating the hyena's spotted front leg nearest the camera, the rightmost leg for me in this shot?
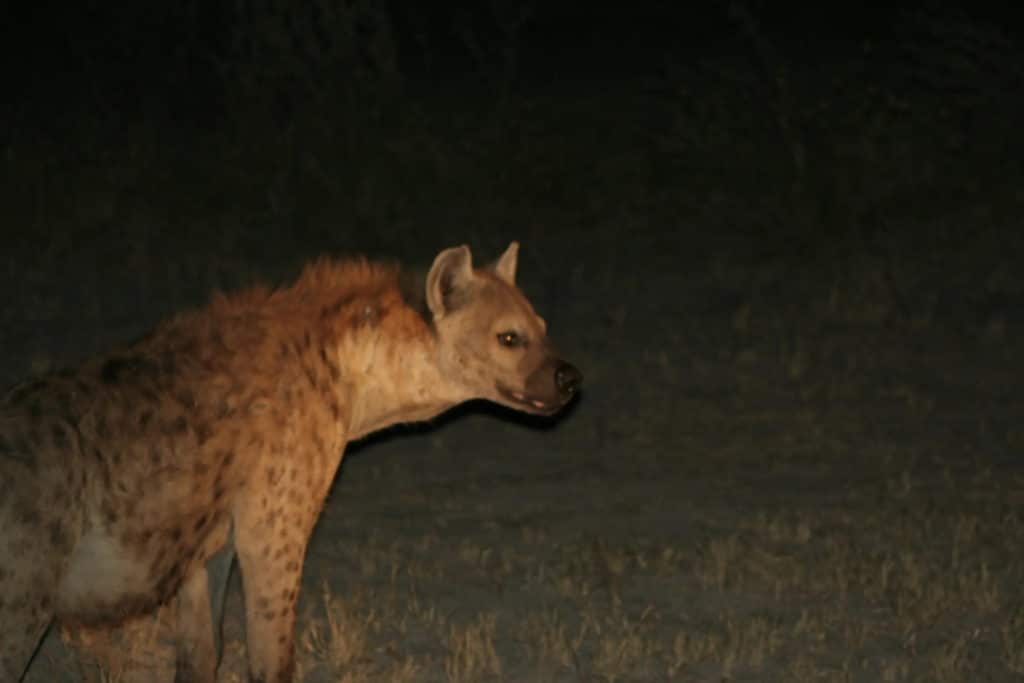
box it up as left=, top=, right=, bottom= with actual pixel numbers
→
left=234, top=489, right=315, bottom=683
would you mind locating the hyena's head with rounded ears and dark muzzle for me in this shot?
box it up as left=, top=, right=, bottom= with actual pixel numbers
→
left=426, top=242, right=583, bottom=415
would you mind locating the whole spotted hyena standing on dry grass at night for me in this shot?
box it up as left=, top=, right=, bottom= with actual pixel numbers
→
left=0, top=242, right=582, bottom=683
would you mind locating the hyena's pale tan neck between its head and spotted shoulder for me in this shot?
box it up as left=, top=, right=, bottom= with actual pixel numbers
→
left=331, top=286, right=470, bottom=439
